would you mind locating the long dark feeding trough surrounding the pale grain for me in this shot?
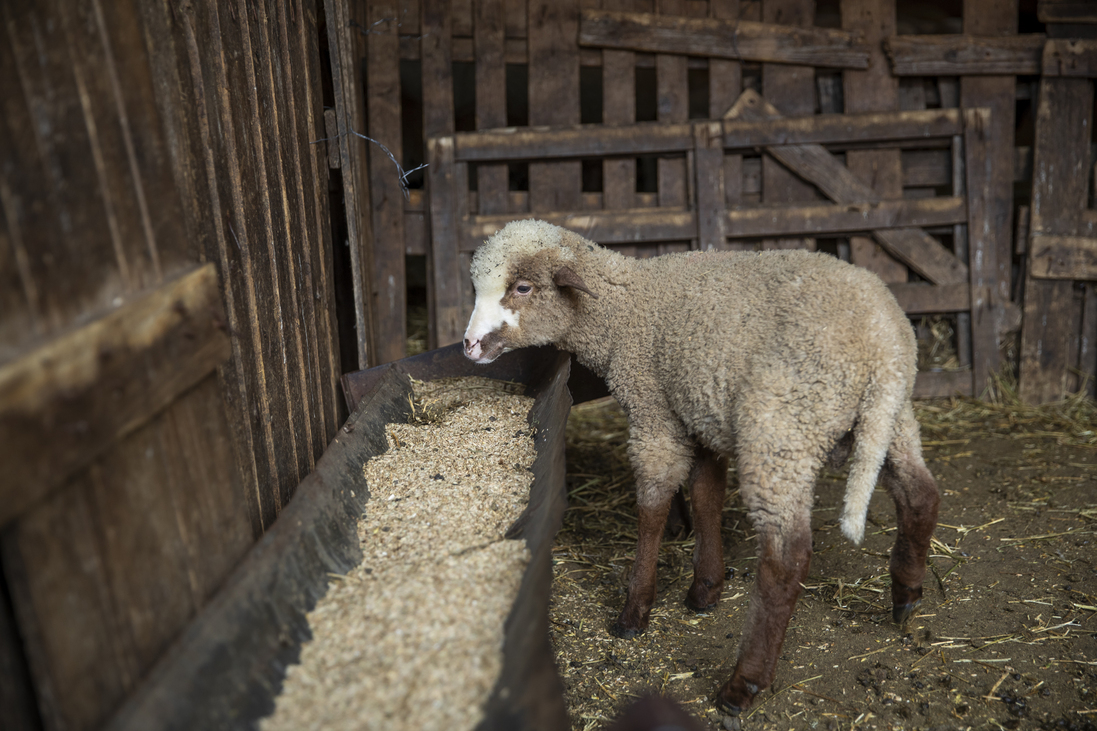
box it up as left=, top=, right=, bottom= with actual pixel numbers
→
left=106, top=346, right=572, bottom=731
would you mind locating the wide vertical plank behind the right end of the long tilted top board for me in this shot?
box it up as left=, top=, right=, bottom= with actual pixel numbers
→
left=841, top=0, right=907, bottom=282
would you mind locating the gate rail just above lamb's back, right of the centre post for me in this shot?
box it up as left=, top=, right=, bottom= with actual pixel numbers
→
left=726, top=198, right=968, bottom=238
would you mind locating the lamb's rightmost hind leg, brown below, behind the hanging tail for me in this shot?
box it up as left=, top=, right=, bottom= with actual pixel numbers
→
left=881, top=405, right=940, bottom=626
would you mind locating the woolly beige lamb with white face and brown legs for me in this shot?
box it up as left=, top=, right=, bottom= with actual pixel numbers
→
left=464, top=221, right=939, bottom=728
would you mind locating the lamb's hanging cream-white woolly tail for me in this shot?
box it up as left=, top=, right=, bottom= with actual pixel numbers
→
left=841, top=381, right=906, bottom=544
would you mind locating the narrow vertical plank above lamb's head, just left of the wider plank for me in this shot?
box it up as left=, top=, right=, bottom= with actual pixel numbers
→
left=473, top=0, right=510, bottom=214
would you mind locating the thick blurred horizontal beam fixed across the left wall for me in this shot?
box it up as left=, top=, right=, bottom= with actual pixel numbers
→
left=0, top=263, right=229, bottom=526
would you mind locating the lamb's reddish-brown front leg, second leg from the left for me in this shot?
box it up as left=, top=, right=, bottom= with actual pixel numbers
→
left=686, top=449, right=727, bottom=611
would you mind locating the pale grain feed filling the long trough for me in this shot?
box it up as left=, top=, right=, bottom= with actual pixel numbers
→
left=261, top=379, right=535, bottom=731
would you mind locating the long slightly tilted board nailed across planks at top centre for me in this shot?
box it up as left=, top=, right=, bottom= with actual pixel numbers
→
left=579, top=10, right=868, bottom=68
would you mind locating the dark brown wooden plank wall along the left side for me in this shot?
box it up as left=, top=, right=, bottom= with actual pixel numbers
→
left=0, top=0, right=346, bottom=729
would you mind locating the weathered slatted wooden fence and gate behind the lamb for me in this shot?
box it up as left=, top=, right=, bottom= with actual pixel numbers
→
left=362, top=0, right=1093, bottom=401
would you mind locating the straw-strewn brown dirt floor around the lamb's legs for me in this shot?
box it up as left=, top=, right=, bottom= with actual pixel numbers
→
left=551, top=392, right=1097, bottom=730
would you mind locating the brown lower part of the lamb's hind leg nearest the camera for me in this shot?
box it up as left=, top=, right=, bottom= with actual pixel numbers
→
left=716, top=510, right=812, bottom=717
